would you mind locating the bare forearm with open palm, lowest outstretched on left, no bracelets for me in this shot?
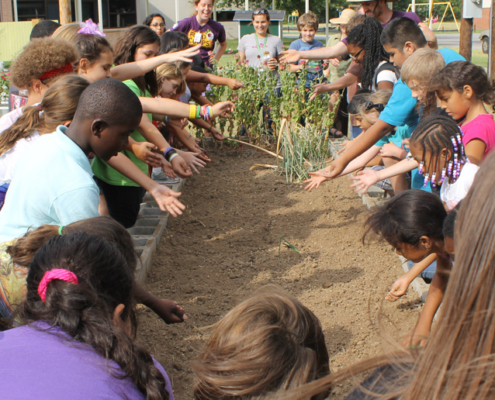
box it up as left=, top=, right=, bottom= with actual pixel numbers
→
left=108, top=153, right=186, bottom=217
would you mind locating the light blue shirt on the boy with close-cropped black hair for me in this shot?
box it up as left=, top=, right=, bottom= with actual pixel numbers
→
left=0, top=126, right=100, bottom=242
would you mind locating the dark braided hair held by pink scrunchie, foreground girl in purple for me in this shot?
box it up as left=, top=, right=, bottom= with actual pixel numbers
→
left=21, top=233, right=169, bottom=400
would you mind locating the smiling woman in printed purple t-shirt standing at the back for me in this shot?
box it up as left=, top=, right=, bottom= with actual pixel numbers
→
left=170, top=0, right=227, bottom=66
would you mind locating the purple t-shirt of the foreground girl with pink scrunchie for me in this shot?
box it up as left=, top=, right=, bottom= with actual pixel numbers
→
left=0, top=322, right=174, bottom=400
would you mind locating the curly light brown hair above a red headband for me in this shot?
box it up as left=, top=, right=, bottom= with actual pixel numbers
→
left=10, top=38, right=78, bottom=89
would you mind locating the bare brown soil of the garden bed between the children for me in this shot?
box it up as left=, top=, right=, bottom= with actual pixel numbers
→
left=139, top=149, right=422, bottom=399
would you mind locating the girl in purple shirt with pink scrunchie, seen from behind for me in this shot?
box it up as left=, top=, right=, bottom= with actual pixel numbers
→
left=0, top=233, right=173, bottom=400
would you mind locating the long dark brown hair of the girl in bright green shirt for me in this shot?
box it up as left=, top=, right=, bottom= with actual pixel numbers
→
left=114, top=25, right=160, bottom=96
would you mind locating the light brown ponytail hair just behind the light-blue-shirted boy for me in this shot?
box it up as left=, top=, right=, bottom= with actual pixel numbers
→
left=0, top=75, right=89, bottom=156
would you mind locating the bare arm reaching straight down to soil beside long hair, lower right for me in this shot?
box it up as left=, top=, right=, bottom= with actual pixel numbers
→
left=402, top=257, right=452, bottom=347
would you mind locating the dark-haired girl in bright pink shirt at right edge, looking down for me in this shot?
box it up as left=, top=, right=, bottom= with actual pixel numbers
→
left=433, top=61, right=495, bottom=165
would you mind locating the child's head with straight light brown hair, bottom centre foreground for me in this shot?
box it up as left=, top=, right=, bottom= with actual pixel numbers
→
left=193, top=286, right=330, bottom=400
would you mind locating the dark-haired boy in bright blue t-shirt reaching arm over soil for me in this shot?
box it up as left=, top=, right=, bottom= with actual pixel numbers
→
left=311, top=17, right=464, bottom=179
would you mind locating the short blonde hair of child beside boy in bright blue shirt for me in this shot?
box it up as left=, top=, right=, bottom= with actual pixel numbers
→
left=400, top=48, right=445, bottom=88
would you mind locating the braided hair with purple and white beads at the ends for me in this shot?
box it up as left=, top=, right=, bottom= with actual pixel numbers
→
left=411, top=115, right=466, bottom=186
